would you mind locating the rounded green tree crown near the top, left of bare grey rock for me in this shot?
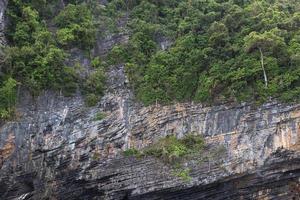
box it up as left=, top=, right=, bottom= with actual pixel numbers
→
left=54, top=4, right=96, bottom=49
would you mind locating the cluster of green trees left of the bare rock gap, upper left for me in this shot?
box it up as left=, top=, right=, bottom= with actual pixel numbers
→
left=0, top=0, right=105, bottom=119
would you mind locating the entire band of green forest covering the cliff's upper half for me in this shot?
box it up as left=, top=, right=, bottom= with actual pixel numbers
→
left=0, top=0, right=300, bottom=118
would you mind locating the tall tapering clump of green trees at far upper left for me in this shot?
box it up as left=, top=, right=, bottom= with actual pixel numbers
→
left=4, top=5, right=70, bottom=93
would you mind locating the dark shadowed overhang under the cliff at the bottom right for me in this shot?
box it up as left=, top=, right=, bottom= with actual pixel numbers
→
left=128, top=150, right=300, bottom=200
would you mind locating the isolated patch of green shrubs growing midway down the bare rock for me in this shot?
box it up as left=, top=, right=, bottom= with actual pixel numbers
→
left=123, top=133, right=226, bottom=181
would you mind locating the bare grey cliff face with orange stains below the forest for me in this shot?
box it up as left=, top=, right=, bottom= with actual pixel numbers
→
left=0, top=1, right=300, bottom=200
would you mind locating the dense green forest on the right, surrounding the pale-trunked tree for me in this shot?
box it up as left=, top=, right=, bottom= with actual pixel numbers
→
left=118, top=0, right=300, bottom=105
